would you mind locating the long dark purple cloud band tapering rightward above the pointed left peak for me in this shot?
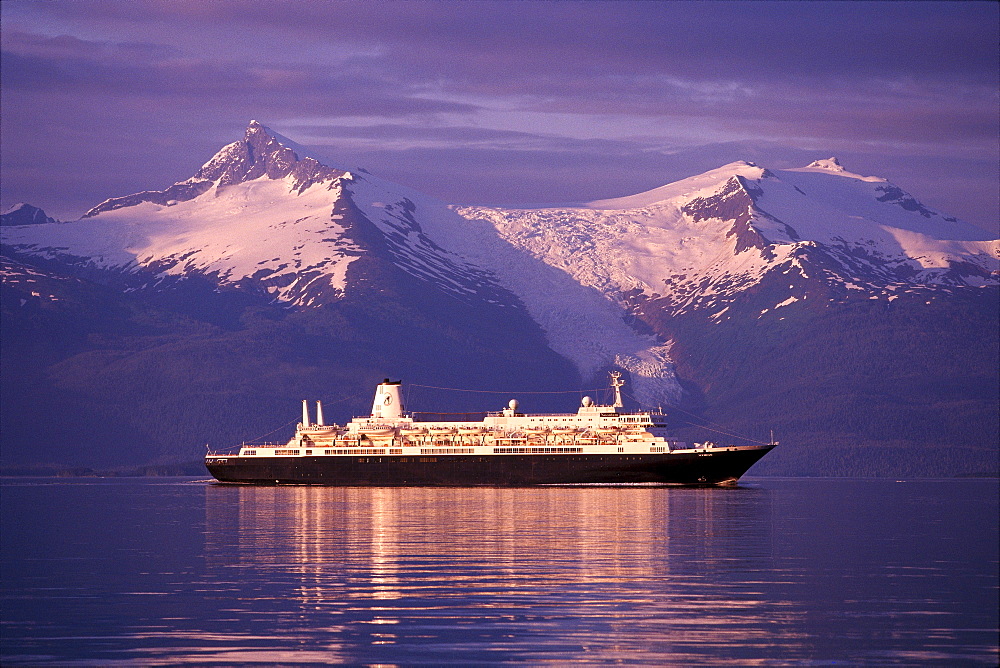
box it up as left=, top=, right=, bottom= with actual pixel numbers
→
left=2, top=32, right=469, bottom=115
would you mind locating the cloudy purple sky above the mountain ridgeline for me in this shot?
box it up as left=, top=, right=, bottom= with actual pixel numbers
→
left=0, top=0, right=1000, bottom=234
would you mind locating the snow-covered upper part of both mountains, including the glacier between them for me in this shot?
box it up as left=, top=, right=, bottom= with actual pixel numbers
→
left=4, top=121, right=1000, bottom=362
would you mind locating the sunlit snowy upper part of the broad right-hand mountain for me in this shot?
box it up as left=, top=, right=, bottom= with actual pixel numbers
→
left=458, top=158, right=1000, bottom=324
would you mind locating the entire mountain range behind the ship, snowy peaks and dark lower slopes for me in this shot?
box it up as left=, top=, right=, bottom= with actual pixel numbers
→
left=3, top=122, right=1000, bottom=475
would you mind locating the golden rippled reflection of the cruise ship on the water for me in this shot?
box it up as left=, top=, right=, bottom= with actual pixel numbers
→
left=206, top=486, right=787, bottom=661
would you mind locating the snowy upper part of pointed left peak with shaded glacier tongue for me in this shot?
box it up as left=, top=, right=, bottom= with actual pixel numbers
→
left=3, top=121, right=680, bottom=404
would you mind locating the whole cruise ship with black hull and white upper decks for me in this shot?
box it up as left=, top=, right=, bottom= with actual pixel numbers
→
left=205, top=372, right=777, bottom=486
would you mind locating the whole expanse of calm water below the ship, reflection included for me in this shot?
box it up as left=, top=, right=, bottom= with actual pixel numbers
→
left=0, top=478, right=998, bottom=666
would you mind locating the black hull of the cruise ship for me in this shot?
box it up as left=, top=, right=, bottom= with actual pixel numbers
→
left=206, top=447, right=772, bottom=487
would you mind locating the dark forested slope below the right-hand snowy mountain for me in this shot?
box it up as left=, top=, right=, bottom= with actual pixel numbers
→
left=653, top=286, right=1000, bottom=477
